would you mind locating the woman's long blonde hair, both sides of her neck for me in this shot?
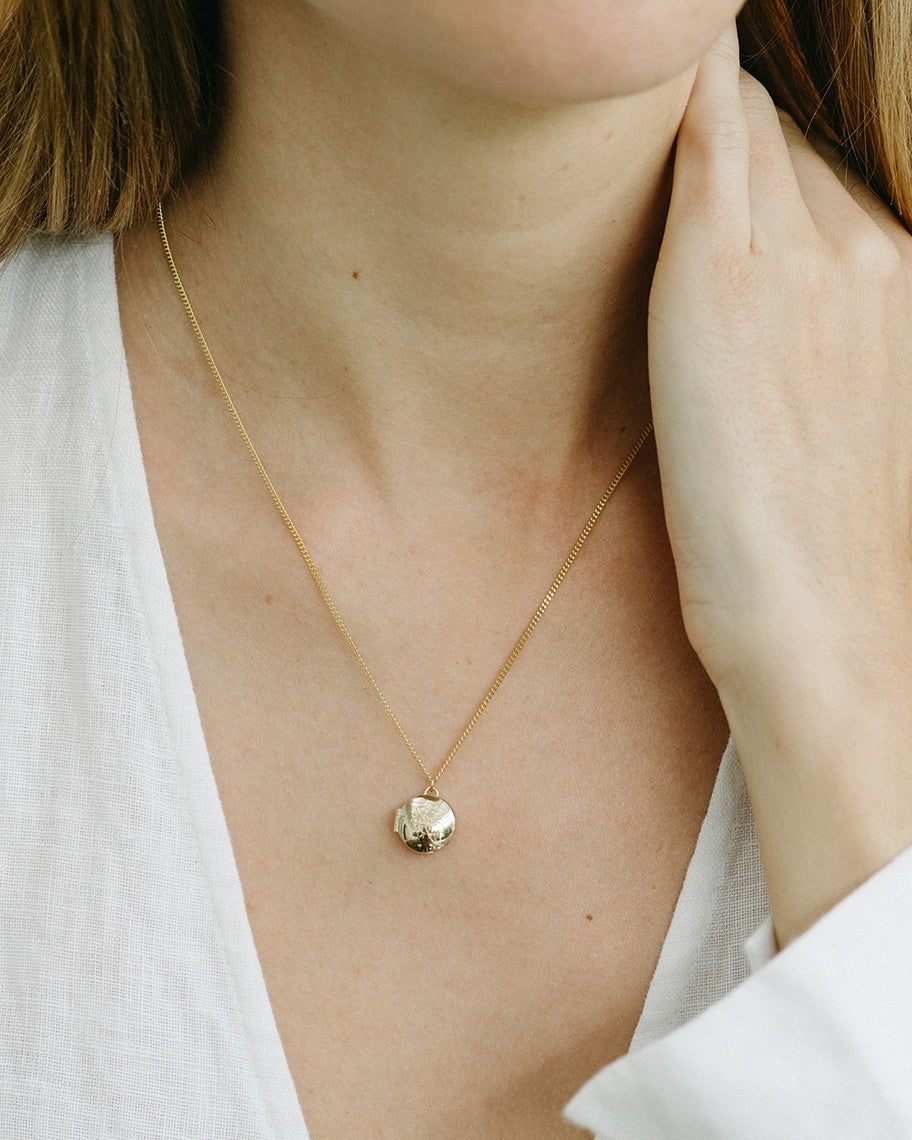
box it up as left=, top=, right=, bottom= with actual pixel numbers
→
left=0, top=0, right=912, bottom=257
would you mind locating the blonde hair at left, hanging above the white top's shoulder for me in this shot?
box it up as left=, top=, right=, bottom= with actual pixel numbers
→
left=0, top=0, right=220, bottom=257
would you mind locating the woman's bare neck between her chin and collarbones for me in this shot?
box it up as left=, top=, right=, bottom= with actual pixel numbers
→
left=161, top=0, right=691, bottom=483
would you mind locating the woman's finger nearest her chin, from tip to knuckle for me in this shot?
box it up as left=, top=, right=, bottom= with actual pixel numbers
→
left=669, top=22, right=750, bottom=243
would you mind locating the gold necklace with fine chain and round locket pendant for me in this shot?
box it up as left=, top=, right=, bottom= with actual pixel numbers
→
left=157, top=202, right=652, bottom=852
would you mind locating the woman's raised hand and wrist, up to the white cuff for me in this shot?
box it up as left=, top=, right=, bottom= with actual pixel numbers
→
left=650, top=20, right=912, bottom=943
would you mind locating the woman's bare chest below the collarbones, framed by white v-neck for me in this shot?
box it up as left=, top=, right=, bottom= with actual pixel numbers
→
left=124, top=298, right=727, bottom=1140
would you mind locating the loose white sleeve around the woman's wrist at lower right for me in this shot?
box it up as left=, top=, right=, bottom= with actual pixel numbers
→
left=567, top=849, right=912, bottom=1140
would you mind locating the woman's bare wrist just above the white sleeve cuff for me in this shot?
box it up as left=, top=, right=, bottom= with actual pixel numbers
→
left=719, top=606, right=912, bottom=945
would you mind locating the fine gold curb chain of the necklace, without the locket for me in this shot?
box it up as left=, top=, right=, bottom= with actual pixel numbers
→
left=157, top=202, right=652, bottom=791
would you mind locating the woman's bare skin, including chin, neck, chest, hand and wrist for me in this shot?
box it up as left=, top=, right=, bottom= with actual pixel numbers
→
left=117, top=0, right=912, bottom=1138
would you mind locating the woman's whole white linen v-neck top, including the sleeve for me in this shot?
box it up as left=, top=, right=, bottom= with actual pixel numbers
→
left=0, top=238, right=912, bottom=1140
